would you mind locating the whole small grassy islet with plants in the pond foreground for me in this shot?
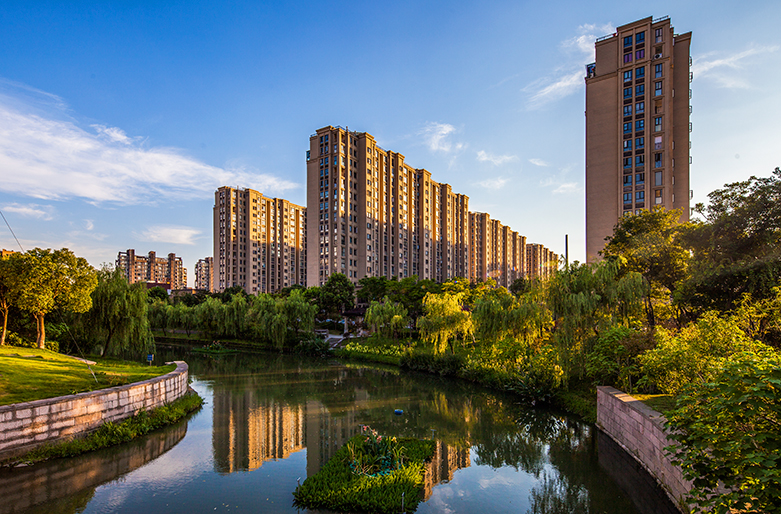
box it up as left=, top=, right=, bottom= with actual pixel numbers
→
left=293, top=427, right=434, bottom=514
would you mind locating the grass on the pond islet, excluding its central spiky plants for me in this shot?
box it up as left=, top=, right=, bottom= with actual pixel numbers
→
left=293, top=434, right=435, bottom=514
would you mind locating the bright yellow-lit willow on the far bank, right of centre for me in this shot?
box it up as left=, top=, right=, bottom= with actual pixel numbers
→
left=417, top=293, right=474, bottom=354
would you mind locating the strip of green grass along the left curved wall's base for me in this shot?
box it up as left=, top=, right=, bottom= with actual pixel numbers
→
left=2, top=389, right=203, bottom=467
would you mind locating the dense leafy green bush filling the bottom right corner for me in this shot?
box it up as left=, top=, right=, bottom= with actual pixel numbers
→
left=667, top=353, right=781, bottom=514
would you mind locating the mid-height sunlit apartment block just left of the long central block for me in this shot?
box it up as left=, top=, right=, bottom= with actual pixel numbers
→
left=218, top=186, right=307, bottom=294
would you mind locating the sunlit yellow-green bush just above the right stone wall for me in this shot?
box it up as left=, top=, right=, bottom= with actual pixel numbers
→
left=638, top=311, right=769, bottom=395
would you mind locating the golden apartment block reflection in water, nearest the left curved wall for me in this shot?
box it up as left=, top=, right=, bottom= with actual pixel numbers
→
left=212, top=391, right=304, bottom=473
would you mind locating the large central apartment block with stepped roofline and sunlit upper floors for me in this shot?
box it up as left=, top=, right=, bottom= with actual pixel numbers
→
left=307, top=126, right=469, bottom=286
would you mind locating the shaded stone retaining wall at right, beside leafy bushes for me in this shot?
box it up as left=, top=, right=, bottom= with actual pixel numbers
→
left=597, top=386, right=691, bottom=512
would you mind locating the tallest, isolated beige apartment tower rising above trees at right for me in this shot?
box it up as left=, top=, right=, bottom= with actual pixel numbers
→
left=586, top=16, right=691, bottom=262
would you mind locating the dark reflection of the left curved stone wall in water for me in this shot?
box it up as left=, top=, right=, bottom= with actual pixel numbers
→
left=0, top=414, right=187, bottom=514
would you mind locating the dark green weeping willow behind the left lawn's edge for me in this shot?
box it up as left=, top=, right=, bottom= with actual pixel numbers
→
left=78, top=267, right=154, bottom=355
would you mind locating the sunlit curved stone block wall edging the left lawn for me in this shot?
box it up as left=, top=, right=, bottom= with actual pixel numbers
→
left=0, top=361, right=188, bottom=461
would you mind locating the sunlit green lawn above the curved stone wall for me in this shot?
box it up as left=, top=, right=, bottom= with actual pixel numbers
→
left=0, top=346, right=176, bottom=405
